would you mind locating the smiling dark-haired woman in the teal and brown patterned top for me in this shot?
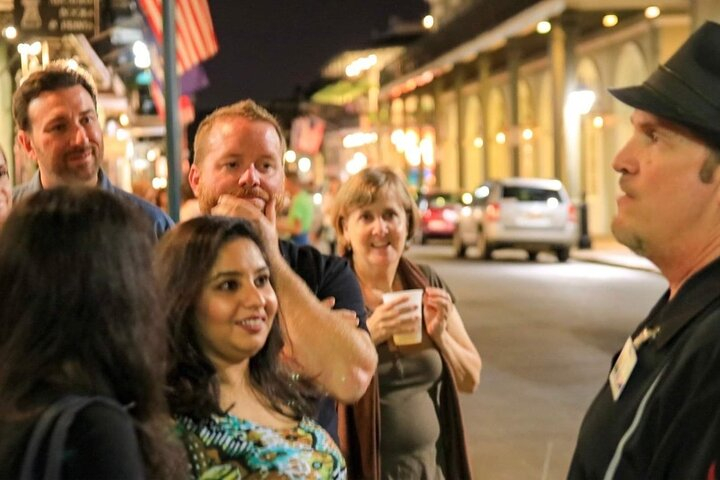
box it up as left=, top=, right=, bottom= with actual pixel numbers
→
left=156, top=216, right=345, bottom=479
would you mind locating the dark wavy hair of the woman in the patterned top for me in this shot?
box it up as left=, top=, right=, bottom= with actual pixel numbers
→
left=155, top=216, right=315, bottom=421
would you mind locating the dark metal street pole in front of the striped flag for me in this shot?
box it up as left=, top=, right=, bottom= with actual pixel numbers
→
left=162, top=0, right=182, bottom=222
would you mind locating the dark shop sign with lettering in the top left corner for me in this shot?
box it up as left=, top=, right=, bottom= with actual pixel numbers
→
left=14, top=0, right=100, bottom=37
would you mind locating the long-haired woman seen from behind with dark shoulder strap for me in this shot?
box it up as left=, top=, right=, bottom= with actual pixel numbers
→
left=0, top=187, right=183, bottom=479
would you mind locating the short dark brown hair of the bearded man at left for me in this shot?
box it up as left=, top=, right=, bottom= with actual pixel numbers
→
left=12, top=60, right=97, bottom=131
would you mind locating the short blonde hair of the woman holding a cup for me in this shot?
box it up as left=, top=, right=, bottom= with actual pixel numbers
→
left=333, top=167, right=420, bottom=255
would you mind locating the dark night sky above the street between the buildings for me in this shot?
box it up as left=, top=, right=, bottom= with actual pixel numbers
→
left=197, top=0, right=428, bottom=110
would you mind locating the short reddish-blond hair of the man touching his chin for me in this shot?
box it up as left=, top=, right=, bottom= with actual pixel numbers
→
left=193, top=99, right=287, bottom=165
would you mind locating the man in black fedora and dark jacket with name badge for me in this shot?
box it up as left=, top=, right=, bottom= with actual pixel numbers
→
left=568, top=22, right=720, bottom=479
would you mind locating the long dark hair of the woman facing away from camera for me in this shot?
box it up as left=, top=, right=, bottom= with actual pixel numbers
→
left=0, top=187, right=181, bottom=477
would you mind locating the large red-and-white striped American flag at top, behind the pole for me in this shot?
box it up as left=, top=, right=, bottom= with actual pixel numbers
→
left=138, top=0, right=218, bottom=75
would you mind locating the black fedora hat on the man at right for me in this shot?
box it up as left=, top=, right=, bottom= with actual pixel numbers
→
left=610, top=22, right=720, bottom=147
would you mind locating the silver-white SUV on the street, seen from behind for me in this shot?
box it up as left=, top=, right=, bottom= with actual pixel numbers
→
left=453, top=178, right=578, bottom=262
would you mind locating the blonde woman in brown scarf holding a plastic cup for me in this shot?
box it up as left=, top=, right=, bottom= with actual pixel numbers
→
left=333, top=167, right=481, bottom=479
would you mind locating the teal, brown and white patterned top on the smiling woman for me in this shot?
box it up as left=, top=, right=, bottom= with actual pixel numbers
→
left=177, top=414, right=347, bottom=480
